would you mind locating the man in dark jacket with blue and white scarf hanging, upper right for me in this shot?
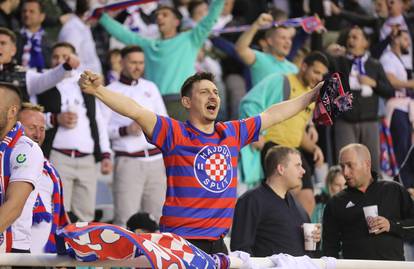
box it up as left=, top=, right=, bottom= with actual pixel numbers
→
left=330, top=26, right=394, bottom=171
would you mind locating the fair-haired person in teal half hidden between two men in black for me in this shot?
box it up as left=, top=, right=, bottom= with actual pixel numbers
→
left=311, top=165, right=345, bottom=223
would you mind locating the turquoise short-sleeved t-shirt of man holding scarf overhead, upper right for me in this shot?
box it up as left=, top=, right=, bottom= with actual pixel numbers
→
left=250, top=50, right=299, bottom=86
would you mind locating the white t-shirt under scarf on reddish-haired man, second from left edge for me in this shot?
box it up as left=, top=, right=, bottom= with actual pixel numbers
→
left=30, top=165, right=53, bottom=254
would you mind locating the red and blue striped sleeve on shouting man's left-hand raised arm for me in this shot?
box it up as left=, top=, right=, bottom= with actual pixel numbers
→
left=147, top=115, right=180, bottom=153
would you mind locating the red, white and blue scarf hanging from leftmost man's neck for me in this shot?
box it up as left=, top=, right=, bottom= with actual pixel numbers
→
left=0, top=122, right=24, bottom=253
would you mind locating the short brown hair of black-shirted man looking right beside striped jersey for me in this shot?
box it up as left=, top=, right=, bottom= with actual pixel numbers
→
left=264, top=145, right=300, bottom=178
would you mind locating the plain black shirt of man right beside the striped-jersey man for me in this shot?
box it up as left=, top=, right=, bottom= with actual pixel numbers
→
left=230, top=183, right=310, bottom=257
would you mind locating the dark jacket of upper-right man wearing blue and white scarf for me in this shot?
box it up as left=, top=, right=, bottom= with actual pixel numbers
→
left=330, top=56, right=394, bottom=122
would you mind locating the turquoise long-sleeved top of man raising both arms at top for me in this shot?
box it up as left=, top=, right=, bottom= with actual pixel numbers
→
left=99, top=0, right=225, bottom=95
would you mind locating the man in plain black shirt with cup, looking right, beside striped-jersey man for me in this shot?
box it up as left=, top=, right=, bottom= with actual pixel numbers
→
left=231, top=146, right=320, bottom=257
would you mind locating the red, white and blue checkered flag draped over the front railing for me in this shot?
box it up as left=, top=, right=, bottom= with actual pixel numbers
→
left=58, top=222, right=230, bottom=269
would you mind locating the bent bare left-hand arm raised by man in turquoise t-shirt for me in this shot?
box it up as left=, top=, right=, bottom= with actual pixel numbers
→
left=236, top=13, right=273, bottom=65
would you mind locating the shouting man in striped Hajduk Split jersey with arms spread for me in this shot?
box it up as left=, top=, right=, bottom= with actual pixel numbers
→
left=79, top=71, right=321, bottom=254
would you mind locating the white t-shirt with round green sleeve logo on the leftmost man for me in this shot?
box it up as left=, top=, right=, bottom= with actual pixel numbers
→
left=9, top=136, right=44, bottom=250
